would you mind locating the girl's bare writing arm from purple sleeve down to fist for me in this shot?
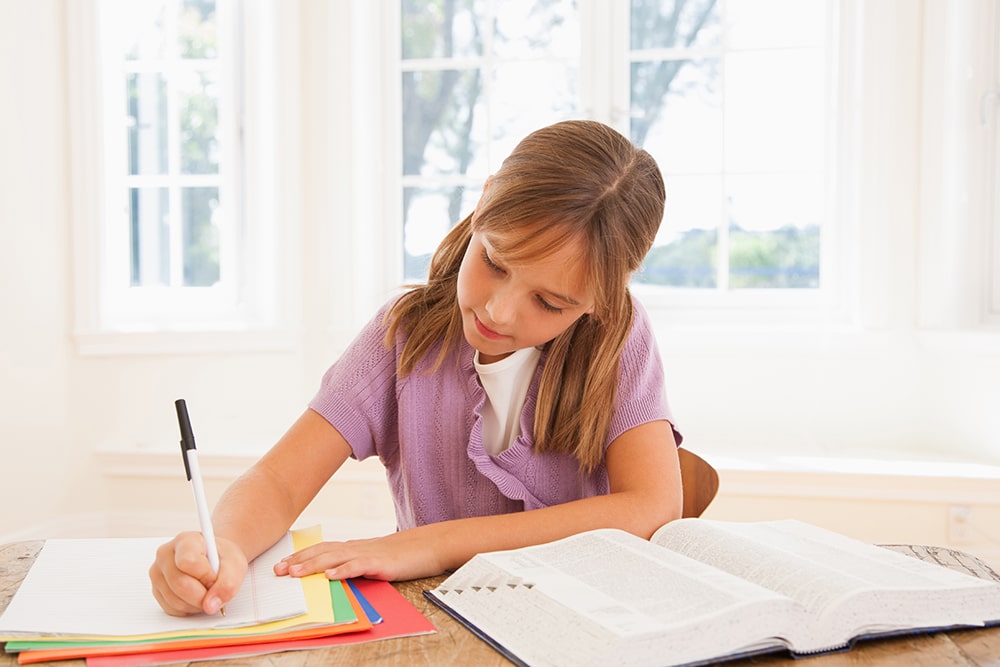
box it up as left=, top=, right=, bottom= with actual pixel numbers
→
left=149, top=410, right=351, bottom=615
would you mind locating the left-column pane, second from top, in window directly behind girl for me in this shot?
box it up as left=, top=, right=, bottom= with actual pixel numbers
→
left=403, top=69, right=486, bottom=175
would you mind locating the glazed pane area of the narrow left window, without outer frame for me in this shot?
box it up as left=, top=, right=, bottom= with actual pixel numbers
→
left=115, top=0, right=230, bottom=287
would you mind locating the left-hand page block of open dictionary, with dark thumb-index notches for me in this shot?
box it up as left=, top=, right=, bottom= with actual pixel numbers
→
left=432, top=531, right=802, bottom=665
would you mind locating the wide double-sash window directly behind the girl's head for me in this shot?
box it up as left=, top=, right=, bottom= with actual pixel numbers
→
left=400, top=0, right=833, bottom=304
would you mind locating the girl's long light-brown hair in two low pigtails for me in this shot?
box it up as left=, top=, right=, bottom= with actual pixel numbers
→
left=386, top=120, right=665, bottom=472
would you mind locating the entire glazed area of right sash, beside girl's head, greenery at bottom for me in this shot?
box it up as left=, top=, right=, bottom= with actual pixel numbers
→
left=629, top=0, right=828, bottom=289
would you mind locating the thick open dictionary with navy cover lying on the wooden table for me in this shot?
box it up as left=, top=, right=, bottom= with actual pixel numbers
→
left=425, top=519, right=1000, bottom=667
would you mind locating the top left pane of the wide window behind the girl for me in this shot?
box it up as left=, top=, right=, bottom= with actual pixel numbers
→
left=400, top=0, right=485, bottom=60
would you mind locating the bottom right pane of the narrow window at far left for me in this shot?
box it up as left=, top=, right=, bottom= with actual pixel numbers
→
left=181, top=188, right=221, bottom=287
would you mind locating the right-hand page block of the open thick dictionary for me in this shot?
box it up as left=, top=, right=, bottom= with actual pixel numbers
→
left=653, top=519, right=1000, bottom=649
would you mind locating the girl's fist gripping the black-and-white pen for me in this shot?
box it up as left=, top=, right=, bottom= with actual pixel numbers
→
left=149, top=532, right=248, bottom=616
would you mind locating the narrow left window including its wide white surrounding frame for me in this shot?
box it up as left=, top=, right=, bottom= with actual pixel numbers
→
left=71, top=0, right=286, bottom=350
